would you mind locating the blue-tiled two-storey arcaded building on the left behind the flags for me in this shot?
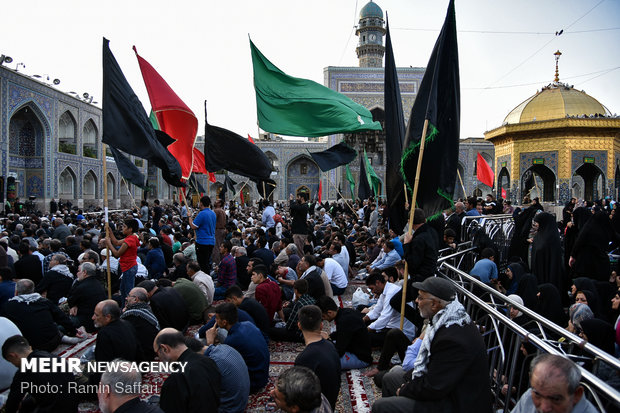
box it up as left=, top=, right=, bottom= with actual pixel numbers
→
left=0, top=65, right=146, bottom=211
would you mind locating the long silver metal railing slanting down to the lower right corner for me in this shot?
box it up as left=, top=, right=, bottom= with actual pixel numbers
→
left=438, top=260, right=620, bottom=412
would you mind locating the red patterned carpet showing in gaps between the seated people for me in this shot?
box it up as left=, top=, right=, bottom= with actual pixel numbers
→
left=56, top=281, right=381, bottom=413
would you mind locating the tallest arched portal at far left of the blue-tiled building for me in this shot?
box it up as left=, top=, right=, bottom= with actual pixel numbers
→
left=9, top=105, right=46, bottom=198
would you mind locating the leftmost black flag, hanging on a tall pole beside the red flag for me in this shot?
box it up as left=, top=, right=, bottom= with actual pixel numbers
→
left=102, top=38, right=183, bottom=186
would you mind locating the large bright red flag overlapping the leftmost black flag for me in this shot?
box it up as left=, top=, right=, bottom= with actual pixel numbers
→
left=133, top=46, right=196, bottom=179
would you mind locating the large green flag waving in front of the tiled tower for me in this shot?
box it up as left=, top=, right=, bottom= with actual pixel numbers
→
left=250, top=40, right=381, bottom=137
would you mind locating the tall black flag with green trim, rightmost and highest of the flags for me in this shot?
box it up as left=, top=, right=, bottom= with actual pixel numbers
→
left=401, top=0, right=461, bottom=217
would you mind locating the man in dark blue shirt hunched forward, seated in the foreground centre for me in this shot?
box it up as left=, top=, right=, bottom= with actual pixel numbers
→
left=206, top=303, right=269, bottom=393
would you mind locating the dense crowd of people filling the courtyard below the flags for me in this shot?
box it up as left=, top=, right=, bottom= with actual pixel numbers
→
left=0, top=195, right=620, bottom=413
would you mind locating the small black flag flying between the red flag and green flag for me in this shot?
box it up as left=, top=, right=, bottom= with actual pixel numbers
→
left=203, top=102, right=271, bottom=182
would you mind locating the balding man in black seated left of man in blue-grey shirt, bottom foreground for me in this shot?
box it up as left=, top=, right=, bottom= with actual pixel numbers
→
left=153, top=328, right=222, bottom=413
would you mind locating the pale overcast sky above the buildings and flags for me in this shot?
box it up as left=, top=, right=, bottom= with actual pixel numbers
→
left=0, top=0, right=620, bottom=138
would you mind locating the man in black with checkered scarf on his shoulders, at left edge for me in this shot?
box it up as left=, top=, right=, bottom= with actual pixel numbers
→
left=4, top=278, right=79, bottom=351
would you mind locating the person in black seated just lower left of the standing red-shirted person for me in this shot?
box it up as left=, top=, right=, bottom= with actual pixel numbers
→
left=67, top=262, right=108, bottom=333
